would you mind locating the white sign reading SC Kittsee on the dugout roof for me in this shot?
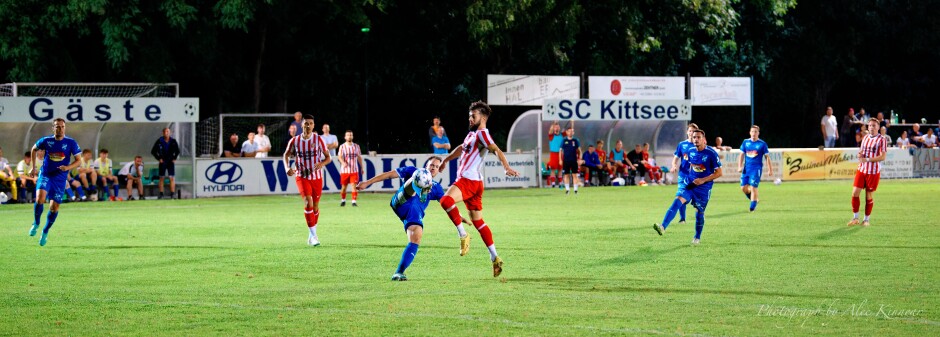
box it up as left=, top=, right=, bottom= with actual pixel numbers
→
left=542, top=99, right=692, bottom=121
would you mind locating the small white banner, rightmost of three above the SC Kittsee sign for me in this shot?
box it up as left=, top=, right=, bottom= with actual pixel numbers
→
left=692, top=77, right=751, bottom=106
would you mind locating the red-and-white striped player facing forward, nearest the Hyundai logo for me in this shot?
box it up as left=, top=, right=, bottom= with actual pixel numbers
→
left=283, top=115, right=333, bottom=246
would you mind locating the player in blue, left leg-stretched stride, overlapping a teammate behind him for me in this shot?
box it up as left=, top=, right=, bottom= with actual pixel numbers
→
left=653, top=130, right=721, bottom=245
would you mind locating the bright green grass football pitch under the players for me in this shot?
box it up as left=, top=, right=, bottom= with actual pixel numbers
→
left=0, top=180, right=940, bottom=336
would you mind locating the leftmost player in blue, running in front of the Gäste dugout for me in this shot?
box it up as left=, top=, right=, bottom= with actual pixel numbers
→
left=29, top=118, right=82, bottom=246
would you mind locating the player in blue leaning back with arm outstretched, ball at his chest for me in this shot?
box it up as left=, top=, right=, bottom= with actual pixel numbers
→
left=356, top=156, right=444, bottom=281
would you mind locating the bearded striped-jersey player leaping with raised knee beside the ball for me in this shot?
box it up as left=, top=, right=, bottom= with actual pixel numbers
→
left=440, top=101, right=519, bottom=277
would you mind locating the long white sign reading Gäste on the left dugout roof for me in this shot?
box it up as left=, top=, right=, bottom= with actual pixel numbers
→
left=0, top=97, right=199, bottom=123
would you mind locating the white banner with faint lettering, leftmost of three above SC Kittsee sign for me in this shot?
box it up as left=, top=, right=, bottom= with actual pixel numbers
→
left=486, top=75, right=581, bottom=106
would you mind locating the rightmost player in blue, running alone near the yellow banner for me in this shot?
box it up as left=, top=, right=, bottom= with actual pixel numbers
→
left=738, top=125, right=774, bottom=212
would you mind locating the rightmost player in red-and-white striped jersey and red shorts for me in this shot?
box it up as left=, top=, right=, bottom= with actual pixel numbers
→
left=849, top=118, right=888, bottom=227
